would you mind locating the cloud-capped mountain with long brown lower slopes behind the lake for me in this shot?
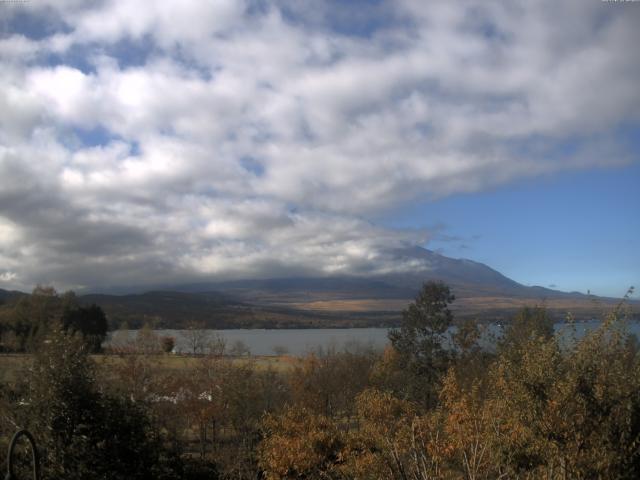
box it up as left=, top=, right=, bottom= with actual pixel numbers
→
left=0, top=247, right=640, bottom=328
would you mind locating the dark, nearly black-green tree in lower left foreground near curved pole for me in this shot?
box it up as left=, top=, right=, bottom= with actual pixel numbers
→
left=18, top=326, right=175, bottom=480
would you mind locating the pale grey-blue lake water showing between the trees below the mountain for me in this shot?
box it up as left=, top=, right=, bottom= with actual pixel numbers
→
left=105, top=320, right=640, bottom=355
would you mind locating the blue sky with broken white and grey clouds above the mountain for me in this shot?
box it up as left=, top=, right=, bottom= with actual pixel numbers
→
left=0, top=0, right=640, bottom=296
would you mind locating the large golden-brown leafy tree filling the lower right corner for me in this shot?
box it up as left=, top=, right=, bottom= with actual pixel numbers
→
left=484, top=315, right=640, bottom=478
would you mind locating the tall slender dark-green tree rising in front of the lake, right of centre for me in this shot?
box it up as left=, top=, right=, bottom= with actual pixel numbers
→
left=389, top=281, right=455, bottom=406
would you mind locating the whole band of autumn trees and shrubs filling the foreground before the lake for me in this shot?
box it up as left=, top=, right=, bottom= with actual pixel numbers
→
left=0, top=282, right=640, bottom=480
